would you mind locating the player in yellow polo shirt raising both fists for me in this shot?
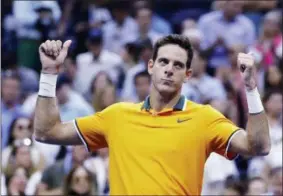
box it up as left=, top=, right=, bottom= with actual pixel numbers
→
left=34, top=35, right=270, bottom=195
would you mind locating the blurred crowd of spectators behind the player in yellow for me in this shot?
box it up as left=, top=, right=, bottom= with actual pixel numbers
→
left=1, top=0, right=283, bottom=195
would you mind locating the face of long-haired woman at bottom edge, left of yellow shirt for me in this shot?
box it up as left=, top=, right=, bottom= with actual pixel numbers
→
left=71, top=167, right=91, bottom=194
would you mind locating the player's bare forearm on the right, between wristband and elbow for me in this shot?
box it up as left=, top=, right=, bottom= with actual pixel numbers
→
left=246, top=111, right=271, bottom=155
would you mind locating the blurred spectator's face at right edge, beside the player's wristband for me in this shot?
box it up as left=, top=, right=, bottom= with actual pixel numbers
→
left=266, top=93, right=282, bottom=117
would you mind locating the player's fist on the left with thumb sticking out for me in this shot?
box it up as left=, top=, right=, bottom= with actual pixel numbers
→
left=39, top=40, right=72, bottom=74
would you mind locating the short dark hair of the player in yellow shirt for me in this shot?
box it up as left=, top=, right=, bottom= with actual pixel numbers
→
left=152, top=34, right=193, bottom=69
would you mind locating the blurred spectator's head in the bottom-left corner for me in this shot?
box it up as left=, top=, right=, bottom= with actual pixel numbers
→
left=7, top=167, right=28, bottom=196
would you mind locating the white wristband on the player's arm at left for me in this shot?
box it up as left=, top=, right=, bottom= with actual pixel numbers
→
left=38, top=73, right=58, bottom=97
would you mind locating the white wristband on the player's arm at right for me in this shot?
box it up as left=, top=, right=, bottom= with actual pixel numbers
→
left=246, top=88, right=264, bottom=114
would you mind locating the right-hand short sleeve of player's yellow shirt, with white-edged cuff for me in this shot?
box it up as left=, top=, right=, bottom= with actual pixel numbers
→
left=205, top=106, right=241, bottom=160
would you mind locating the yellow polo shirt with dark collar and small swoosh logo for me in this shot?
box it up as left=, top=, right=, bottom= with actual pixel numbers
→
left=75, top=96, right=239, bottom=195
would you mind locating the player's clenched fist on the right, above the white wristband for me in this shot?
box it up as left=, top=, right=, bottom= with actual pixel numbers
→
left=238, top=53, right=256, bottom=91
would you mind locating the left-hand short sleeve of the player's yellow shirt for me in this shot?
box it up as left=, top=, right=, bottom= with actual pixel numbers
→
left=74, top=106, right=118, bottom=152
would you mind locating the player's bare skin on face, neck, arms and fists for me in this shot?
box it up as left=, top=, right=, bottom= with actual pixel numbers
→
left=34, top=40, right=270, bottom=164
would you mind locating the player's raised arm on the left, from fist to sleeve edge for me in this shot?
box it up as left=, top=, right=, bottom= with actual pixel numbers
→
left=34, top=40, right=82, bottom=145
